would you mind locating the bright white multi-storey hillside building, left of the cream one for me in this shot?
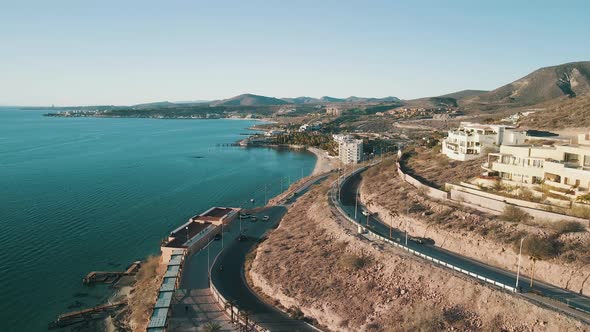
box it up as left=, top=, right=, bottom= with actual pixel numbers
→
left=442, top=122, right=527, bottom=161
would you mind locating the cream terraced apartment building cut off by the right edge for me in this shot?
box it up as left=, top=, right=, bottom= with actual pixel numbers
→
left=484, top=134, right=590, bottom=194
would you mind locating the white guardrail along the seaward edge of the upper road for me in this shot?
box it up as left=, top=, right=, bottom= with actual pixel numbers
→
left=330, top=165, right=517, bottom=292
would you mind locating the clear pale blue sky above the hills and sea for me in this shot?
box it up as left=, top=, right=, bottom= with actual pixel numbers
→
left=0, top=0, right=590, bottom=105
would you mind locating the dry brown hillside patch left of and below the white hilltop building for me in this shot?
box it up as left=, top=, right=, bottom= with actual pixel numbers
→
left=400, top=146, right=486, bottom=189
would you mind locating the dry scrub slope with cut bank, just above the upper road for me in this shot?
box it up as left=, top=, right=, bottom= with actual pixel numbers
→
left=361, top=160, right=590, bottom=294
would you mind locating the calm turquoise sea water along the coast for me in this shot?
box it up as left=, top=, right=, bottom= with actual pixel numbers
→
left=0, top=108, right=315, bottom=331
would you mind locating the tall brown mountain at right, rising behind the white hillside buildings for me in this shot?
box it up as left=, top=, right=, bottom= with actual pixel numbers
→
left=464, top=61, right=590, bottom=107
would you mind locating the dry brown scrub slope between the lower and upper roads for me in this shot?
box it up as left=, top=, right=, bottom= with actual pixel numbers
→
left=249, top=175, right=583, bottom=331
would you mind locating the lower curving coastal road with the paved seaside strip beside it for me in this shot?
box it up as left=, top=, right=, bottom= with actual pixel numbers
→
left=170, top=174, right=329, bottom=331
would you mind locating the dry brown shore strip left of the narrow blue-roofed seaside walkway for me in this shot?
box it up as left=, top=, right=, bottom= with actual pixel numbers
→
left=121, top=256, right=165, bottom=331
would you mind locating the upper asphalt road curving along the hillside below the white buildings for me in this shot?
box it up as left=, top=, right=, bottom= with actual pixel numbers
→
left=339, top=170, right=590, bottom=323
